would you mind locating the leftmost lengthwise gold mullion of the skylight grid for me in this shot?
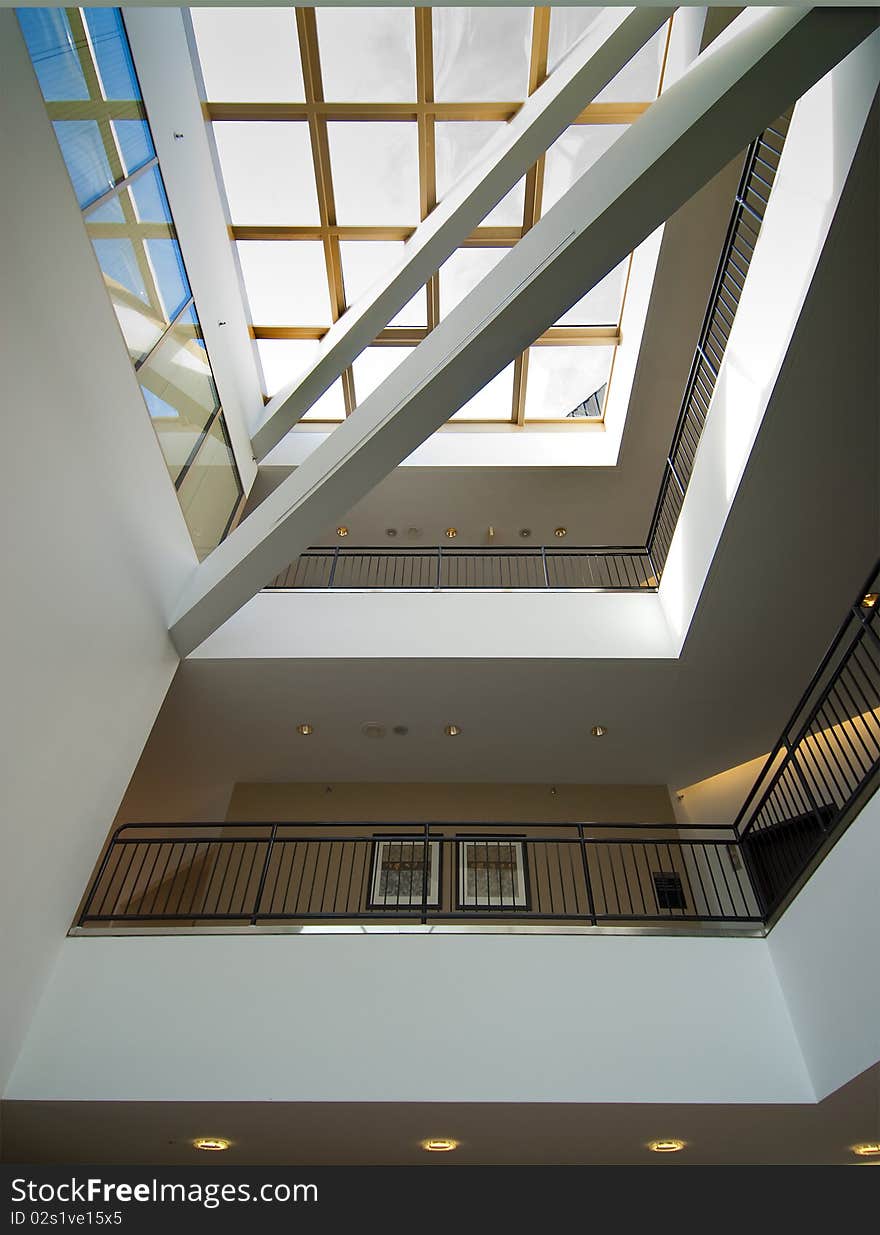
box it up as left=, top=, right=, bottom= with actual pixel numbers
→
left=296, top=9, right=357, bottom=416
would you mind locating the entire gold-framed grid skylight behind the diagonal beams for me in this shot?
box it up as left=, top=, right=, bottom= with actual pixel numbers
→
left=190, top=7, right=671, bottom=427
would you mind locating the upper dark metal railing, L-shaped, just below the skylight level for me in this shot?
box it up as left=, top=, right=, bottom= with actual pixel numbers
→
left=267, top=114, right=790, bottom=592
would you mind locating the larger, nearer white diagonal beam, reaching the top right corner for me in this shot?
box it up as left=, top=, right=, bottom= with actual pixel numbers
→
left=172, top=9, right=880, bottom=656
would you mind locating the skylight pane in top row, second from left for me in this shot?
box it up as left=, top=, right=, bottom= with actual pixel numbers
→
left=316, top=9, right=416, bottom=103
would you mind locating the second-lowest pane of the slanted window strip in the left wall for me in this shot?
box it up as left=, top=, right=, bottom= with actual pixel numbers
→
left=137, top=309, right=217, bottom=480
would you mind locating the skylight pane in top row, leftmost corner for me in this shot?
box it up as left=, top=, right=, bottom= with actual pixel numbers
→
left=190, top=7, right=305, bottom=103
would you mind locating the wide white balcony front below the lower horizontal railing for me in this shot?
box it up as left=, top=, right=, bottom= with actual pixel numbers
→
left=7, top=935, right=813, bottom=1103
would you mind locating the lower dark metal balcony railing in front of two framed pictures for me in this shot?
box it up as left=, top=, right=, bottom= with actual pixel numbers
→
left=78, top=562, right=880, bottom=929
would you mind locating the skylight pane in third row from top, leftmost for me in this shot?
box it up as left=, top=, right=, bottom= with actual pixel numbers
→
left=238, top=240, right=332, bottom=326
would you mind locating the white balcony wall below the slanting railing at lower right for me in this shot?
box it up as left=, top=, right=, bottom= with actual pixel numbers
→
left=768, top=794, right=880, bottom=1098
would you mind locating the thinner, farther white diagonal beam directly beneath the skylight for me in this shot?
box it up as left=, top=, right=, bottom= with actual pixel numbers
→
left=252, top=9, right=673, bottom=461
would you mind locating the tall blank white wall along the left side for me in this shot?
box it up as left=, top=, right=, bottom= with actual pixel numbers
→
left=0, top=10, right=195, bottom=1092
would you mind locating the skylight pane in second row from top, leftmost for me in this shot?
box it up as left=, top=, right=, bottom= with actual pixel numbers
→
left=214, top=121, right=320, bottom=226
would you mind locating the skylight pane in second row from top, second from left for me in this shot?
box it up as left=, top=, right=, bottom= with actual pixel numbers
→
left=327, top=121, right=420, bottom=226
